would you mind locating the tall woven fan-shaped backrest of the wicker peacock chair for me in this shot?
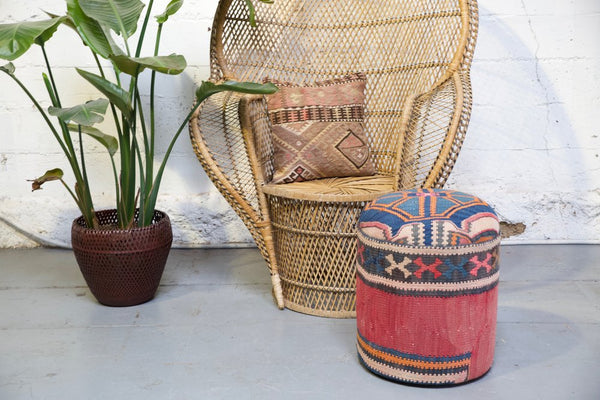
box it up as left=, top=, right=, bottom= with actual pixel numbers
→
left=211, top=0, right=476, bottom=175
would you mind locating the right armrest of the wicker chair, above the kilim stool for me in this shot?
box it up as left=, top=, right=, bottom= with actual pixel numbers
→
left=396, top=71, right=472, bottom=189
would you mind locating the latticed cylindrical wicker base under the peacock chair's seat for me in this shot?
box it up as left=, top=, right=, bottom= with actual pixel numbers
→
left=265, top=177, right=391, bottom=318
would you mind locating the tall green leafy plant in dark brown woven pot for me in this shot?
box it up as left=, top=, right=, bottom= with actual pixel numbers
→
left=0, top=0, right=277, bottom=306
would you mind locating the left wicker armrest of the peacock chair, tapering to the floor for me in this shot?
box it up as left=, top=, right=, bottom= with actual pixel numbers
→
left=190, top=86, right=284, bottom=308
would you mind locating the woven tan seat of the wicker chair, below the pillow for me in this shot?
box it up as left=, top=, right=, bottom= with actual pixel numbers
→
left=263, top=175, right=395, bottom=202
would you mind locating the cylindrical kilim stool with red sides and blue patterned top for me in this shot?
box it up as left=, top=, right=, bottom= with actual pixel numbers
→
left=356, top=189, right=500, bottom=385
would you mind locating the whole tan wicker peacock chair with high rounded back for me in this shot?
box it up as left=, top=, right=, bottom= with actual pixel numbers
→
left=190, top=0, right=478, bottom=317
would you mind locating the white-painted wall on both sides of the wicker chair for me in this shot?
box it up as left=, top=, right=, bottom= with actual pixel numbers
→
left=0, top=0, right=600, bottom=247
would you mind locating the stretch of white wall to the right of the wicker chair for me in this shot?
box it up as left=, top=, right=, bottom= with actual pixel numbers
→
left=448, top=0, right=600, bottom=242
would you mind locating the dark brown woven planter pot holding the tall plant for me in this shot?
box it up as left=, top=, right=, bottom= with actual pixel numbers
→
left=71, top=210, right=173, bottom=307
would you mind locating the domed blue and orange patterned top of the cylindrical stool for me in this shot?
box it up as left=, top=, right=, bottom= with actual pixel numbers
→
left=358, top=189, right=500, bottom=247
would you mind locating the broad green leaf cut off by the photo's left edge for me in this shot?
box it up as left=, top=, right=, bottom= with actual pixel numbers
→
left=0, top=18, right=62, bottom=61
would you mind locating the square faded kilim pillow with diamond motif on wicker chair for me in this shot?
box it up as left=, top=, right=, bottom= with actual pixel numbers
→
left=266, top=74, right=375, bottom=183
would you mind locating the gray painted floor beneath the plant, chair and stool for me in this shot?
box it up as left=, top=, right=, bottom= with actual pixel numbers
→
left=0, top=245, right=600, bottom=400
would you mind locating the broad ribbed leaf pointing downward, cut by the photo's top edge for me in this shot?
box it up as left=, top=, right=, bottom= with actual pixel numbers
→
left=79, top=0, right=144, bottom=40
